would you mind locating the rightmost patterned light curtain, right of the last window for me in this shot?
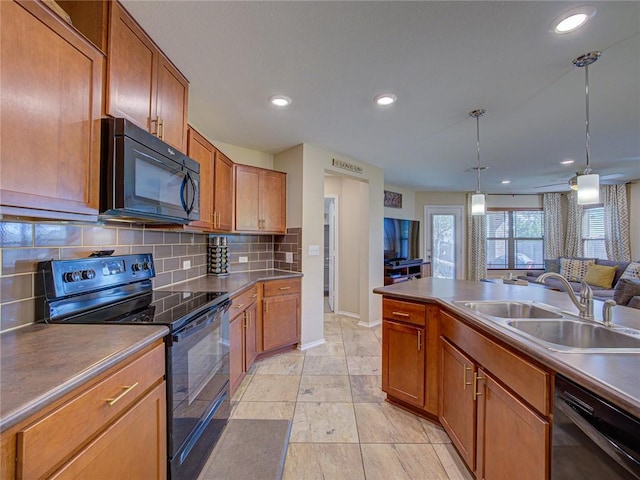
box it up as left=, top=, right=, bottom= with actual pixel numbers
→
left=600, top=185, right=631, bottom=262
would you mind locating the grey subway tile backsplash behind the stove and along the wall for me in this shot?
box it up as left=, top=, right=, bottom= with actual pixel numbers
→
left=0, top=221, right=301, bottom=331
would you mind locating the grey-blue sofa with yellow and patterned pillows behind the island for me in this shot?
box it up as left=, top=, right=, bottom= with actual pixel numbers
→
left=518, top=257, right=640, bottom=309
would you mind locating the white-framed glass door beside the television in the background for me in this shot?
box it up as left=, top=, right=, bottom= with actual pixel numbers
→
left=424, top=205, right=464, bottom=279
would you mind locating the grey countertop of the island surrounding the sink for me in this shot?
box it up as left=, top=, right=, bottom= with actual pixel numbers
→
left=373, top=277, right=640, bottom=417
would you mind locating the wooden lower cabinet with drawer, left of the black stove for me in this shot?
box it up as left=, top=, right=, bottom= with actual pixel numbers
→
left=0, top=340, right=167, bottom=480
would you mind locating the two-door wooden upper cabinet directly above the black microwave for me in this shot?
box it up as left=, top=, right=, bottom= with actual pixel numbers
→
left=106, top=2, right=189, bottom=152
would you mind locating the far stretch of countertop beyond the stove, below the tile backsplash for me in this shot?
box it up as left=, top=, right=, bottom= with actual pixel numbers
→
left=160, top=269, right=302, bottom=296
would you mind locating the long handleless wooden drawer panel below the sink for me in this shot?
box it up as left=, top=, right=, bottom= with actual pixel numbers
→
left=440, top=312, right=551, bottom=416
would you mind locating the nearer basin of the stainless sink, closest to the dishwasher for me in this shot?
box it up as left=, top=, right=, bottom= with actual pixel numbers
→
left=505, top=319, right=640, bottom=351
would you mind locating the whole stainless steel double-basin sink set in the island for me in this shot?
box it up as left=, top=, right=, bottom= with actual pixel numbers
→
left=453, top=301, right=640, bottom=353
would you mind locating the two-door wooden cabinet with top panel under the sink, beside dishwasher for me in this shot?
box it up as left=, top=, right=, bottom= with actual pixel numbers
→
left=438, top=312, right=551, bottom=480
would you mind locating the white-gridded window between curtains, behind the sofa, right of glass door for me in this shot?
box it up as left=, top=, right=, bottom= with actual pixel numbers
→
left=486, top=210, right=544, bottom=270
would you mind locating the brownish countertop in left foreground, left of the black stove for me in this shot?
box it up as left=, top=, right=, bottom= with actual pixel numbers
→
left=0, top=323, right=169, bottom=431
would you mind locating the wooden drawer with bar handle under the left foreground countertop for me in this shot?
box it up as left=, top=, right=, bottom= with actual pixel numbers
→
left=17, top=344, right=165, bottom=478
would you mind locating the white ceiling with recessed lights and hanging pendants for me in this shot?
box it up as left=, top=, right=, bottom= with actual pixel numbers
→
left=123, top=0, right=640, bottom=193
